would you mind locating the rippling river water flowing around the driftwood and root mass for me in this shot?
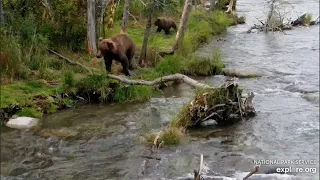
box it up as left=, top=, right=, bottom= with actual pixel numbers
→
left=1, top=0, right=319, bottom=180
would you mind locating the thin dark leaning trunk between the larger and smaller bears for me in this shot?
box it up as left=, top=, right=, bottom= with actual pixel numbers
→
left=139, top=0, right=156, bottom=67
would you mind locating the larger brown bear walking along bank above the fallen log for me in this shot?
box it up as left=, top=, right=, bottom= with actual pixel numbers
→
left=97, top=33, right=136, bottom=76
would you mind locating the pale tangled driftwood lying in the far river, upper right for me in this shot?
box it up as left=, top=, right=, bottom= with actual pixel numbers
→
left=247, top=13, right=319, bottom=33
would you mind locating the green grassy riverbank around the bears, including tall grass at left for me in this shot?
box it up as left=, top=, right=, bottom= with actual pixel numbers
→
left=0, top=1, right=245, bottom=122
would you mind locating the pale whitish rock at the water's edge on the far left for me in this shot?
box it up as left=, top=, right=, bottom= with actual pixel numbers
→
left=6, top=117, right=39, bottom=129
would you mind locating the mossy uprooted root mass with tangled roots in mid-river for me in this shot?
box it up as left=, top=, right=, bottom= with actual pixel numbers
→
left=174, top=80, right=256, bottom=127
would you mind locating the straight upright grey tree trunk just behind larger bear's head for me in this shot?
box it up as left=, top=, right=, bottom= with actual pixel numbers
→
left=87, top=0, right=97, bottom=55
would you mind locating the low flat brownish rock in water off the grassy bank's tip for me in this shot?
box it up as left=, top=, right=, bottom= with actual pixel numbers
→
left=222, top=67, right=262, bottom=78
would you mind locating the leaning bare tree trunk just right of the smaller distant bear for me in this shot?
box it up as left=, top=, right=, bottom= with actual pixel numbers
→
left=172, top=0, right=191, bottom=52
